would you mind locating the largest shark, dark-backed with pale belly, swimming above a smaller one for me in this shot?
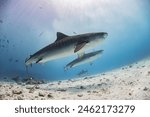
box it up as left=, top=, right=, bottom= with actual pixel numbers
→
left=25, top=32, right=108, bottom=66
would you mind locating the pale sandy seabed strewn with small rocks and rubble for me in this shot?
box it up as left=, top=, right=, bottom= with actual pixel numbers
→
left=0, top=59, right=150, bottom=100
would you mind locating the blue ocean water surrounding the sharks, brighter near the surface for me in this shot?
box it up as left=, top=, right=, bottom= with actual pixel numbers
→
left=0, top=0, right=150, bottom=81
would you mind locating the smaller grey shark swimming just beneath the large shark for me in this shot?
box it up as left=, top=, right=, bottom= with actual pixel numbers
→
left=64, top=50, right=104, bottom=71
